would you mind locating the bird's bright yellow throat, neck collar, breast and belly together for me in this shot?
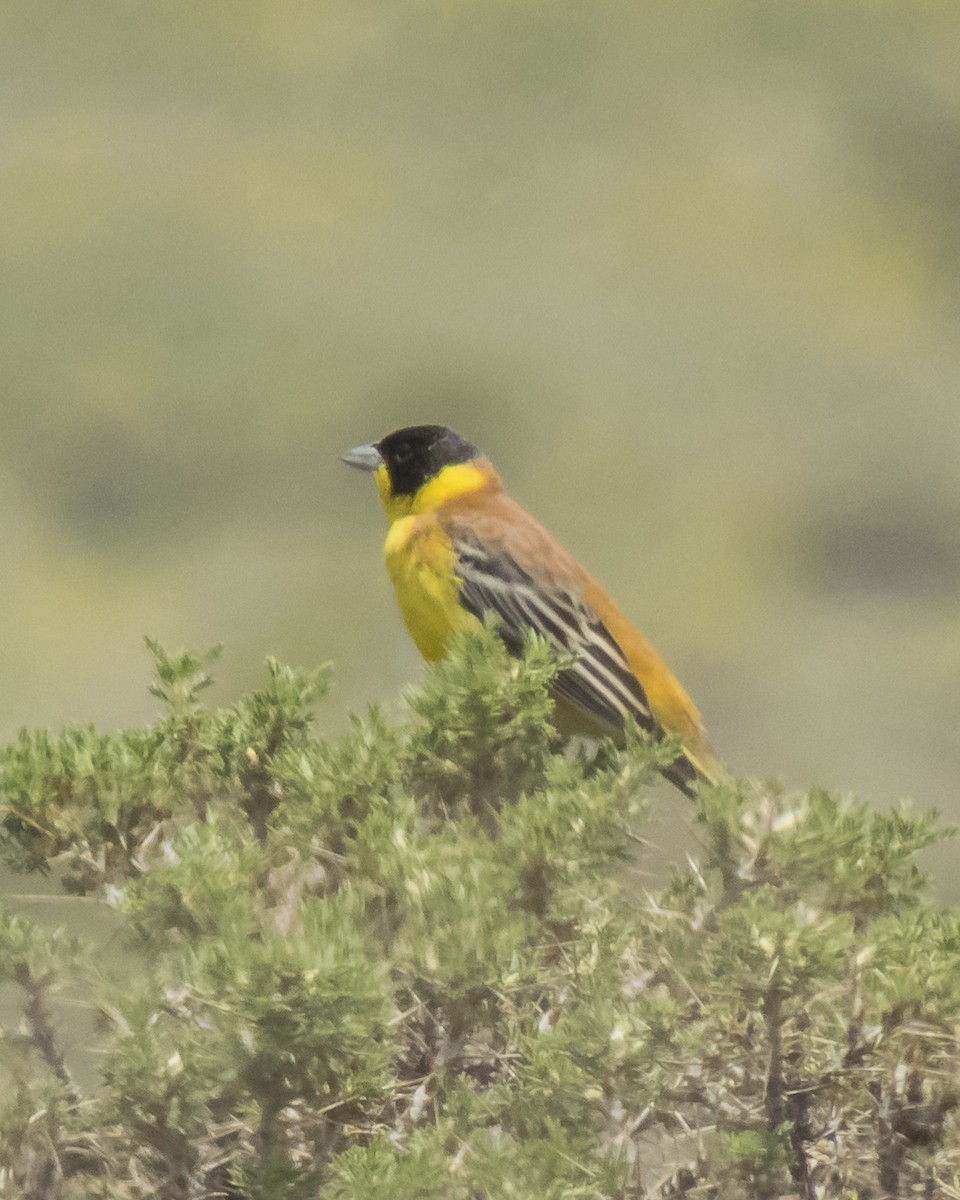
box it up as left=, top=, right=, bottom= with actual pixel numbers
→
left=374, top=462, right=491, bottom=662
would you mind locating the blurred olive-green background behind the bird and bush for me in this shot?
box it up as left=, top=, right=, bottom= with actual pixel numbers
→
left=0, top=0, right=960, bottom=844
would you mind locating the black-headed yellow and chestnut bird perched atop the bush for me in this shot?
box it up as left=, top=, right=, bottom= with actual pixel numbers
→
left=341, top=425, right=725, bottom=798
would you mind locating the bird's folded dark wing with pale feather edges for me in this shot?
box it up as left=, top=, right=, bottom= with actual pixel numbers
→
left=454, top=530, right=662, bottom=733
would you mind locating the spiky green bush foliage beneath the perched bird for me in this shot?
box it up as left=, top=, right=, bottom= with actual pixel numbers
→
left=0, top=629, right=960, bottom=1200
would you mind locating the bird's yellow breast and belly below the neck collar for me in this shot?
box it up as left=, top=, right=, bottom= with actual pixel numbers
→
left=384, top=516, right=476, bottom=662
